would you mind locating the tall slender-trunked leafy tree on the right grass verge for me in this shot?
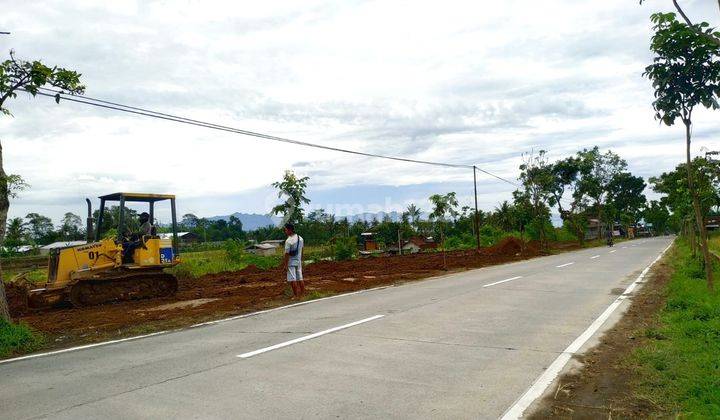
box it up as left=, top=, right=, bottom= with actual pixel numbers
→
left=644, top=13, right=720, bottom=290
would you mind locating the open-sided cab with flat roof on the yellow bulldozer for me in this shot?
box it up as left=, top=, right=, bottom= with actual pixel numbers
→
left=95, top=192, right=179, bottom=263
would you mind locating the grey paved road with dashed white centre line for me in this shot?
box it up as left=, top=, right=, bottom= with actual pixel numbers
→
left=0, top=238, right=670, bottom=419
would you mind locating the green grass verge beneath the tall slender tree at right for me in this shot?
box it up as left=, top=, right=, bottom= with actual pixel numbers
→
left=632, top=241, right=720, bottom=418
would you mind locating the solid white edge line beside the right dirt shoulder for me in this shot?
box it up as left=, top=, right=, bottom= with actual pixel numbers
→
left=501, top=241, right=674, bottom=420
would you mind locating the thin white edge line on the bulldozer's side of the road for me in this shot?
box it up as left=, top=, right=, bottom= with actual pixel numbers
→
left=0, top=285, right=394, bottom=365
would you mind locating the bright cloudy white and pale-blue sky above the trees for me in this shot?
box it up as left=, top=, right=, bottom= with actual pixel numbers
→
left=0, top=0, right=720, bottom=220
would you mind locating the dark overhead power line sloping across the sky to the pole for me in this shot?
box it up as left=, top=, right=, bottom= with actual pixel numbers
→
left=33, top=88, right=519, bottom=187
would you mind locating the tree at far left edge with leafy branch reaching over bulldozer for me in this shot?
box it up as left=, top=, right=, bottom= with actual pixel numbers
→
left=0, top=51, right=85, bottom=320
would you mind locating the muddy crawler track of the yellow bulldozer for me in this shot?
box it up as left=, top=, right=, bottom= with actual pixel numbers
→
left=70, top=273, right=178, bottom=307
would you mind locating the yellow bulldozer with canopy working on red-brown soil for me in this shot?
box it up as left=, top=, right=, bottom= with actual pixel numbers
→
left=22, top=193, right=180, bottom=308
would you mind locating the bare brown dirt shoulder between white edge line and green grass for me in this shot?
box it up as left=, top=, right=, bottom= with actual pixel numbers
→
left=529, top=251, right=672, bottom=419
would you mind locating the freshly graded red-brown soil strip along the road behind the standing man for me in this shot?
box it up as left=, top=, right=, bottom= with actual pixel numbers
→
left=9, top=238, right=556, bottom=347
